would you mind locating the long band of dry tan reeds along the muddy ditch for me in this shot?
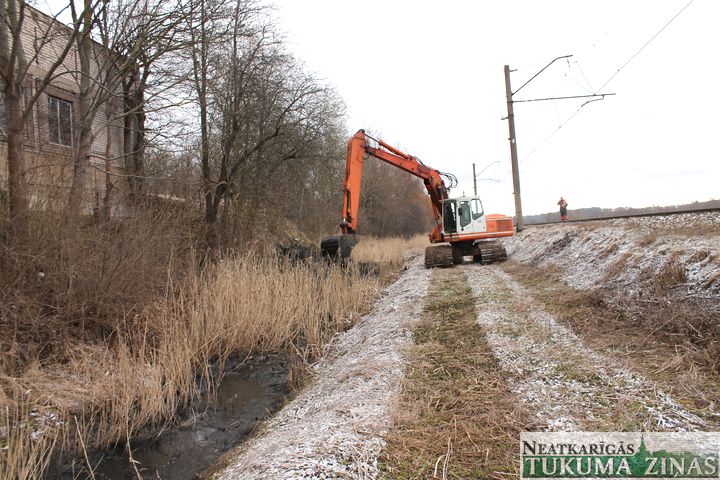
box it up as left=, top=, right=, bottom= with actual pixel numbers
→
left=0, top=254, right=380, bottom=478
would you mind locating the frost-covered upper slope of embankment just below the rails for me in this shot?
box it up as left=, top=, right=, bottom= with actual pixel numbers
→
left=504, top=212, right=720, bottom=303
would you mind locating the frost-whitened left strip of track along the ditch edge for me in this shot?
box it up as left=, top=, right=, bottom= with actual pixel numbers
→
left=214, top=259, right=429, bottom=479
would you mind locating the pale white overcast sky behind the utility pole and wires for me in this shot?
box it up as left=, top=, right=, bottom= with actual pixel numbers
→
left=271, top=0, right=720, bottom=214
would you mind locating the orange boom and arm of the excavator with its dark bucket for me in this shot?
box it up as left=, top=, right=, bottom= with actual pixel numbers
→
left=320, top=130, right=448, bottom=258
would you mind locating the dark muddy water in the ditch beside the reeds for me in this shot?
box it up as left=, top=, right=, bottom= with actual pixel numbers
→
left=47, top=356, right=289, bottom=480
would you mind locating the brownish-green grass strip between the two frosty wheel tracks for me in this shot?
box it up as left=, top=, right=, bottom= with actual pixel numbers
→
left=383, top=269, right=532, bottom=479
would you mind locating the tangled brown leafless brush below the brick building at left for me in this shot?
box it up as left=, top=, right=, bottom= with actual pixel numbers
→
left=0, top=210, right=198, bottom=376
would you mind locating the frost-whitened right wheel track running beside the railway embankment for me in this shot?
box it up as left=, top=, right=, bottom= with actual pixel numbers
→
left=461, top=265, right=717, bottom=431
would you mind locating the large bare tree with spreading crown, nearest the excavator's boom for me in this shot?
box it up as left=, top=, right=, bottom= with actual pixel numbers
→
left=183, top=0, right=342, bottom=250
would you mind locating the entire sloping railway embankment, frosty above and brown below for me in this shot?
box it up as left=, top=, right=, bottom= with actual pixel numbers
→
left=503, top=212, right=720, bottom=412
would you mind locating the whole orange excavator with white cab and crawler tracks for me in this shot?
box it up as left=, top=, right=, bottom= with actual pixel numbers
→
left=320, top=130, right=513, bottom=268
